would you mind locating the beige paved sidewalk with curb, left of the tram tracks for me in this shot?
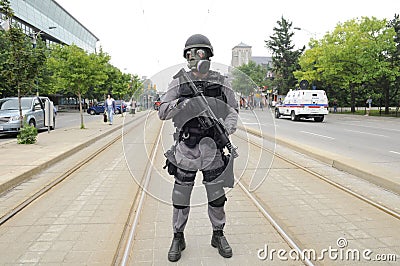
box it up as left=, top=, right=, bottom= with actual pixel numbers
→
left=0, top=112, right=147, bottom=193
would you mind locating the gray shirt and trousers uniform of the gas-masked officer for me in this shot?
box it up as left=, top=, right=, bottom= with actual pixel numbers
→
left=158, top=72, right=238, bottom=233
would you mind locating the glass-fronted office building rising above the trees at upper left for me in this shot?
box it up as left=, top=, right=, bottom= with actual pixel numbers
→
left=0, top=0, right=99, bottom=53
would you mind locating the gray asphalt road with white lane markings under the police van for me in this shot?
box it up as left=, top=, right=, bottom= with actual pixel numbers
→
left=240, top=109, right=400, bottom=176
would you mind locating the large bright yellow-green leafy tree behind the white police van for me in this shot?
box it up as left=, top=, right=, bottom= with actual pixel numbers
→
left=294, top=17, right=399, bottom=112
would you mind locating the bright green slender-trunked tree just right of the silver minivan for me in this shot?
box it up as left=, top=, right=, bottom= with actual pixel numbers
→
left=48, top=45, right=109, bottom=129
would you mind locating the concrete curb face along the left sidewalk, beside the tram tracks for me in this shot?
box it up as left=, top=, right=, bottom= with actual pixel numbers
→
left=0, top=112, right=147, bottom=194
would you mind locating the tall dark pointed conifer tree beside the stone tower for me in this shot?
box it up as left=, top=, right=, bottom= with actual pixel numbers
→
left=265, top=17, right=305, bottom=94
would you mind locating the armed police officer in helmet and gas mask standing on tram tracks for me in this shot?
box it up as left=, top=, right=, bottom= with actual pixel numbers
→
left=158, top=34, right=239, bottom=261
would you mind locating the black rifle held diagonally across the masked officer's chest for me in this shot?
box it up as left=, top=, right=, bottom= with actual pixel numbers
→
left=174, top=68, right=239, bottom=158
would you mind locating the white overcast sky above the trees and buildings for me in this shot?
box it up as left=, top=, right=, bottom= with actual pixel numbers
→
left=56, top=0, right=400, bottom=77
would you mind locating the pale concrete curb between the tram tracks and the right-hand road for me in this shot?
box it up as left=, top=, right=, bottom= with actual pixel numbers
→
left=238, top=126, right=400, bottom=194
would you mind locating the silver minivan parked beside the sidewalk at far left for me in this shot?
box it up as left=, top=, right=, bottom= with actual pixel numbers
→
left=0, top=96, right=56, bottom=133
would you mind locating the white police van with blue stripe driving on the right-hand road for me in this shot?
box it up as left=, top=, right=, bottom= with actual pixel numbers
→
left=275, top=90, right=329, bottom=122
